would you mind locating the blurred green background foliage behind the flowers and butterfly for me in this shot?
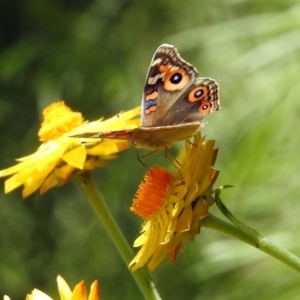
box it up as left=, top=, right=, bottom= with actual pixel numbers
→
left=0, top=0, right=300, bottom=300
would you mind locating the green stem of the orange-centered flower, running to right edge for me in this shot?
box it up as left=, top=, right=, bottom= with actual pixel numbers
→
left=202, top=214, right=300, bottom=272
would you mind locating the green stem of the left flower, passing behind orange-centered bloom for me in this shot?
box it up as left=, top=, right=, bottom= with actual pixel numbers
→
left=74, top=172, right=161, bottom=300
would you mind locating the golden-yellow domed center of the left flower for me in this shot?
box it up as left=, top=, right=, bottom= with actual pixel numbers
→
left=38, top=101, right=83, bottom=142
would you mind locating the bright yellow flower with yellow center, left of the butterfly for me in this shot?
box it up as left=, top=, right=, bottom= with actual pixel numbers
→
left=0, top=101, right=140, bottom=198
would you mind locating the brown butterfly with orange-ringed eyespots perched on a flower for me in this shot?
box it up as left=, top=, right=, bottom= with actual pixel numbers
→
left=76, top=44, right=221, bottom=150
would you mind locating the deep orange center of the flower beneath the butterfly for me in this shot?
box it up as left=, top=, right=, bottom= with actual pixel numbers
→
left=130, top=166, right=173, bottom=220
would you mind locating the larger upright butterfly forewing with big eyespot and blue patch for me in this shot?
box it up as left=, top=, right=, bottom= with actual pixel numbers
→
left=141, top=44, right=198, bottom=127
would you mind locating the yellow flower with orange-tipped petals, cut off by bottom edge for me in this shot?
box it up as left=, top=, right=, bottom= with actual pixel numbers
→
left=26, top=275, right=100, bottom=300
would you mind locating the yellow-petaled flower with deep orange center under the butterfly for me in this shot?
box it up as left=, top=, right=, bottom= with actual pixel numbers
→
left=129, top=133, right=219, bottom=271
